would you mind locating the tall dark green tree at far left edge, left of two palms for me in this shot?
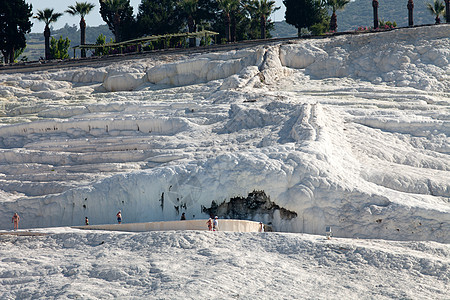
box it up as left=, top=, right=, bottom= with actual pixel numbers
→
left=0, top=0, right=33, bottom=63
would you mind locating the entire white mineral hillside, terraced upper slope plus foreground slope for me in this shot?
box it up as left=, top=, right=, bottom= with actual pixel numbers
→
left=0, top=25, right=450, bottom=299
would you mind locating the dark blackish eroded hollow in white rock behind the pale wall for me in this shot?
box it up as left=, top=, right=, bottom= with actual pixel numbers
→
left=202, top=191, right=297, bottom=225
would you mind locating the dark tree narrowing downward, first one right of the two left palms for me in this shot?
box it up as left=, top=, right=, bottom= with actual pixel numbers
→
left=99, top=0, right=136, bottom=43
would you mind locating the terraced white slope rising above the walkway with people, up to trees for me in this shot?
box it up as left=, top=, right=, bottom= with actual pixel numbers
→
left=0, top=25, right=450, bottom=243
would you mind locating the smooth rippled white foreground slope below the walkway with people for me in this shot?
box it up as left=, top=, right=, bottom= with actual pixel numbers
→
left=0, top=228, right=450, bottom=299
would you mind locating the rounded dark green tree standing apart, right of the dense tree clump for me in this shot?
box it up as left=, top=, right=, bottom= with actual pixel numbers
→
left=283, top=0, right=327, bottom=35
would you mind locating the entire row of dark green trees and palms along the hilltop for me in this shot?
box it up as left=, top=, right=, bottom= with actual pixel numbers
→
left=0, top=0, right=450, bottom=63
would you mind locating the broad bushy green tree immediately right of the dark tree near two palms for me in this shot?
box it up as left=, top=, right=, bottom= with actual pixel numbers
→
left=137, top=0, right=184, bottom=35
